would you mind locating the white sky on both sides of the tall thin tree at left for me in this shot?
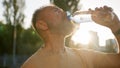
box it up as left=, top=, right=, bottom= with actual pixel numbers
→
left=0, top=0, right=50, bottom=28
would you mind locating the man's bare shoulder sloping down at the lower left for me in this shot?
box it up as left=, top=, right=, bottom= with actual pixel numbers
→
left=21, top=49, right=44, bottom=68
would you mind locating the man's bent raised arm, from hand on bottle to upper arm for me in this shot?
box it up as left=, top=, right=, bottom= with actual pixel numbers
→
left=88, top=6, right=120, bottom=68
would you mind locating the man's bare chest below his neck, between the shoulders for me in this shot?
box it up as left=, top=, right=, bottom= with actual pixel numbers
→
left=36, top=52, right=85, bottom=68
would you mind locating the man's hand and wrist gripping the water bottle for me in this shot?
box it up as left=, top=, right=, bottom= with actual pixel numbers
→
left=90, top=6, right=120, bottom=33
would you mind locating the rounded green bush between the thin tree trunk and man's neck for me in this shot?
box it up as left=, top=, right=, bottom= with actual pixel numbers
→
left=17, top=28, right=43, bottom=55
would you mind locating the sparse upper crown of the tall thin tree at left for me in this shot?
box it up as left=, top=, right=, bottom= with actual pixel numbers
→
left=3, top=0, right=25, bottom=25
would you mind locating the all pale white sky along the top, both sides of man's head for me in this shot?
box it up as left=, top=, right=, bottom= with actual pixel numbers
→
left=0, top=0, right=120, bottom=28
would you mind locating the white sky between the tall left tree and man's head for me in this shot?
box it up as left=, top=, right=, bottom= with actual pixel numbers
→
left=25, top=0, right=50, bottom=28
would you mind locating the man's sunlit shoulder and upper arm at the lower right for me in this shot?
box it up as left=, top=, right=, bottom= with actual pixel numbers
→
left=74, top=49, right=120, bottom=68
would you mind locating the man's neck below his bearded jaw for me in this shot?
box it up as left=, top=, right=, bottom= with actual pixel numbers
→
left=43, top=35, right=65, bottom=54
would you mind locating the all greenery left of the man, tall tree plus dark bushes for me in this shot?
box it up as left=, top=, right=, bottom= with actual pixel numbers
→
left=0, top=0, right=42, bottom=55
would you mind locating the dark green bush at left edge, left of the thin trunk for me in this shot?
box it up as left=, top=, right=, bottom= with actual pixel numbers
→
left=0, top=23, right=13, bottom=54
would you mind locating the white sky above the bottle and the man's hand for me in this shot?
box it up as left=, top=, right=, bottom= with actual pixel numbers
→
left=80, top=0, right=120, bottom=18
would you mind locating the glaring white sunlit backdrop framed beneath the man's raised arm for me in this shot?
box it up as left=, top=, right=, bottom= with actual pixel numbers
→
left=72, top=23, right=114, bottom=46
